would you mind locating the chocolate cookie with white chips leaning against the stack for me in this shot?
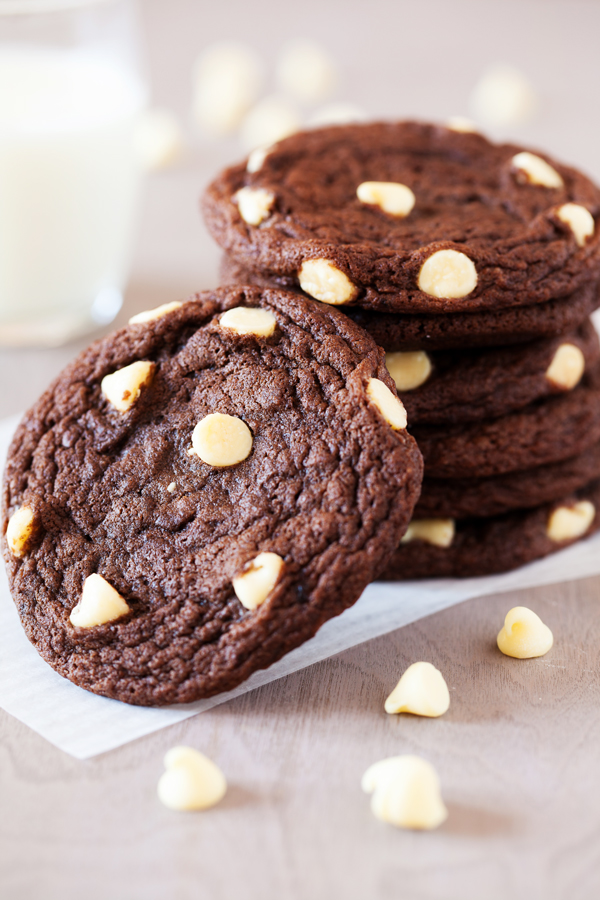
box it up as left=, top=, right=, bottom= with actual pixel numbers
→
left=3, top=288, right=422, bottom=706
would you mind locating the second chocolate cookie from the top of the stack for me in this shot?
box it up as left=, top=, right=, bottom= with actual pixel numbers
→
left=219, top=253, right=600, bottom=350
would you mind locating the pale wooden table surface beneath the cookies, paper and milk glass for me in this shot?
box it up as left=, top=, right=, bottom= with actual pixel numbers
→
left=0, top=0, right=600, bottom=900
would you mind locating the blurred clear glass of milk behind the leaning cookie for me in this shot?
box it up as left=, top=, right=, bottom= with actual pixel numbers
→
left=0, top=0, right=148, bottom=346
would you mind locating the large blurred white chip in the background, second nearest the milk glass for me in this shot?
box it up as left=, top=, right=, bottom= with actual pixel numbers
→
left=192, top=42, right=264, bottom=135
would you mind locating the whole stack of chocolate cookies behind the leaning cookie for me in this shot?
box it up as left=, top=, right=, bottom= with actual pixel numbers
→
left=204, top=122, right=600, bottom=579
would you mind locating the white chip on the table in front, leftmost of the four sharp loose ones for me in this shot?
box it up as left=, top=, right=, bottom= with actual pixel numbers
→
left=157, top=747, right=227, bottom=812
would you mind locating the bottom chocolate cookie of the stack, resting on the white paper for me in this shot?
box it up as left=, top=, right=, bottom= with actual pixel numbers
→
left=381, top=481, right=600, bottom=581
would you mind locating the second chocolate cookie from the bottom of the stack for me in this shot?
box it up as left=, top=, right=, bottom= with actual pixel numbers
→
left=415, top=442, right=600, bottom=519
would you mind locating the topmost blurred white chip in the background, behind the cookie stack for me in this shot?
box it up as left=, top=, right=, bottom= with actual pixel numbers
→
left=277, top=39, right=338, bottom=103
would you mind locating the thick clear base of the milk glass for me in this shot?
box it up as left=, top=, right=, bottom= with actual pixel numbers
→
left=0, top=287, right=123, bottom=347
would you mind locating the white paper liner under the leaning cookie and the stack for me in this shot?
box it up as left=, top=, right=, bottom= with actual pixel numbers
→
left=0, top=408, right=600, bottom=759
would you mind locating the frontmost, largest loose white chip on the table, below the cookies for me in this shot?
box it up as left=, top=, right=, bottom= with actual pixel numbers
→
left=361, top=755, right=448, bottom=830
